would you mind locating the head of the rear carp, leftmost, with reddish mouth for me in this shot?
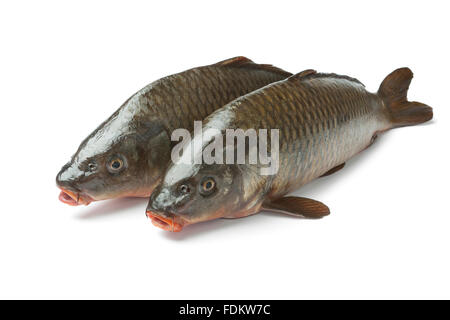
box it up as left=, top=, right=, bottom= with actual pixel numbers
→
left=56, top=117, right=170, bottom=206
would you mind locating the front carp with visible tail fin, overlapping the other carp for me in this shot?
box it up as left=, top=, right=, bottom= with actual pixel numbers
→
left=147, top=68, right=433, bottom=231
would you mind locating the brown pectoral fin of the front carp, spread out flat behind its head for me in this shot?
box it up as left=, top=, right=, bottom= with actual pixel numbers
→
left=262, top=197, right=330, bottom=219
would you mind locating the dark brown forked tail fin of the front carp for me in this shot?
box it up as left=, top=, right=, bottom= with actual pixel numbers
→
left=378, top=68, right=433, bottom=128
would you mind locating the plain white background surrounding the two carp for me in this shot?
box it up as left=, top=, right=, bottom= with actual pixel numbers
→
left=0, top=0, right=450, bottom=299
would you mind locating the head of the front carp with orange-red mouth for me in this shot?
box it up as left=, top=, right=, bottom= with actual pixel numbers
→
left=147, top=157, right=264, bottom=232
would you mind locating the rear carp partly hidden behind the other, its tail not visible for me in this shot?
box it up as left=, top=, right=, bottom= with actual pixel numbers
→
left=56, top=57, right=292, bottom=205
